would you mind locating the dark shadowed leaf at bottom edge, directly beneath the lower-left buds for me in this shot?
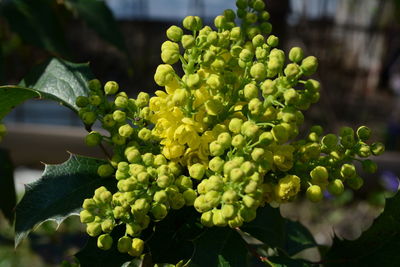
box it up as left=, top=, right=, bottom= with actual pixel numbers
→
left=75, top=225, right=131, bottom=267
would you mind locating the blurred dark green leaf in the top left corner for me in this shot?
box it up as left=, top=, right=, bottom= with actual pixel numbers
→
left=3, top=0, right=69, bottom=56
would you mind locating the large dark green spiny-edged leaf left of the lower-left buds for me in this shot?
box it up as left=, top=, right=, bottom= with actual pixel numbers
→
left=15, top=154, right=115, bottom=246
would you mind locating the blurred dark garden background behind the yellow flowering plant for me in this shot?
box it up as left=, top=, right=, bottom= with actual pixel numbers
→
left=0, top=0, right=400, bottom=267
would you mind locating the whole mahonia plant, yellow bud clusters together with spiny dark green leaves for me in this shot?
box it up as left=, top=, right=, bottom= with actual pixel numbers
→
left=0, top=0, right=400, bottom=266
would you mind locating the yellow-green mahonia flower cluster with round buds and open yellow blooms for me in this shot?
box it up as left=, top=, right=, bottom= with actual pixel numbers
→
left=76, top=0, right=384, bottom=257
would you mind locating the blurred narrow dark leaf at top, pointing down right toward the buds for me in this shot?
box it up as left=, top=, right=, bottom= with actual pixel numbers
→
left=66, top=0, right=126, bottom=52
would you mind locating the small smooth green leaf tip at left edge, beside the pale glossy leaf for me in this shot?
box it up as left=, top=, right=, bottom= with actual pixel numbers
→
left=0, top=86, right=40, bottom=120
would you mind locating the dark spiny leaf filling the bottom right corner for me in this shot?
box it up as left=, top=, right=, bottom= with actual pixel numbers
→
left=323, top=193, right=400, bottom=266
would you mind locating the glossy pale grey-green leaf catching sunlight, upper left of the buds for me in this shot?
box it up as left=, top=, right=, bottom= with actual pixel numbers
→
left=20, top=58, right=94, bottom=112
